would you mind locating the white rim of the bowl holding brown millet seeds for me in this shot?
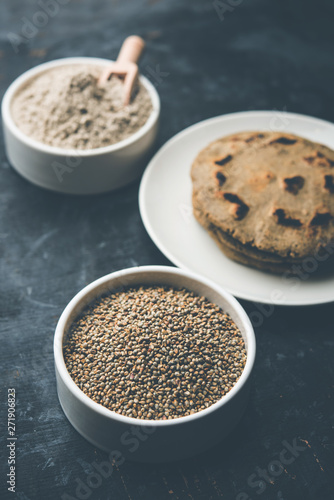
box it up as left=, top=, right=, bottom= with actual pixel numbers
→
left=54, top=266, right=256, bottom=427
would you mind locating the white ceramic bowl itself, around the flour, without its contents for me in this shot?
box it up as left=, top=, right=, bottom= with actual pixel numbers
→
left=1, top=57, right=160, bottom=194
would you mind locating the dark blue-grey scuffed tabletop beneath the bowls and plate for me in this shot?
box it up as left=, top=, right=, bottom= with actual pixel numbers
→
left=0, top=0, right=334, bottom=500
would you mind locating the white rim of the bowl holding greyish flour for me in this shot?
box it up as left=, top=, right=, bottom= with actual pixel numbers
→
left=1, top=57, right=160, bottom=156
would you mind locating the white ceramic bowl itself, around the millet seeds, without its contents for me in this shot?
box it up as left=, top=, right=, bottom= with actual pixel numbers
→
left=54, top=266, right=255, bottom=462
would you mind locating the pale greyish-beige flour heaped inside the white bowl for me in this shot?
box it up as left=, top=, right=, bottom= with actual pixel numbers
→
left=12, top=64, right=152, bottom=149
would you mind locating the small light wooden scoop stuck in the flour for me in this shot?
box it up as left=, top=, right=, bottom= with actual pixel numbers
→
left=98, top=35, right=145, bottom=106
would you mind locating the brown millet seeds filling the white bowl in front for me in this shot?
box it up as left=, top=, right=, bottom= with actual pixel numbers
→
left=64, top=286, right=246, bottom=420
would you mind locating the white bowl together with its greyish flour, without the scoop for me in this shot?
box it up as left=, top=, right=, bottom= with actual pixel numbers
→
left=2, top=57, right=160, bottom=194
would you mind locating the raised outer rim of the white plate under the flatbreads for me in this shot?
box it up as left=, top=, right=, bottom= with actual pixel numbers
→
left=138, top=110, right=334, bottom=307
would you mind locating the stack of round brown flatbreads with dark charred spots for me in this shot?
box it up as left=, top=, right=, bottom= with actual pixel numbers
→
left=191, top=132, right=334, bottom=272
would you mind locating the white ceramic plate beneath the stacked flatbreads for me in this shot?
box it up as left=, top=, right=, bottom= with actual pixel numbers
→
left=139, top=111, right=334, bottom=305
